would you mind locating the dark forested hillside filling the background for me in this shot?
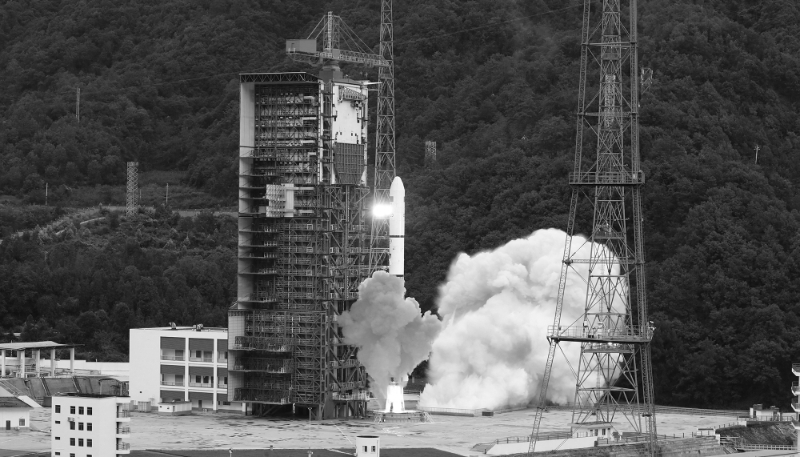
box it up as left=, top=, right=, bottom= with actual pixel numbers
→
left=0, top=0, right=800, bottom=407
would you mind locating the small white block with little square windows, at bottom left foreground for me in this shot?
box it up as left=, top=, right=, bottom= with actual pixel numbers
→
left=50, top=393, right=131, bottom=457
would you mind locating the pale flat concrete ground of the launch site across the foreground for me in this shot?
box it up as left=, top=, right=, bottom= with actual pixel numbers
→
left=0, top=408, right=736, bottom=456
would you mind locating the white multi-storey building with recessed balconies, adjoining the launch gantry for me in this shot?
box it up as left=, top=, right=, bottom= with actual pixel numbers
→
left=129, top=326, right=245, bottom=412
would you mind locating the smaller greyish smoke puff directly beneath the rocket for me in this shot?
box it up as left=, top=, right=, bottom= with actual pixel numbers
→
left=339, top=271, right=441, bottom=398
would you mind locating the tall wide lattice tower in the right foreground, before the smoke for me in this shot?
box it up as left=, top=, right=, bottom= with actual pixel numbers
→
left=529, top=0, right=656, bottom=455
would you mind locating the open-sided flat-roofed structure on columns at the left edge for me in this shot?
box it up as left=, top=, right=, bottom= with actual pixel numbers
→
left=0, top=341, right=82, bottom=378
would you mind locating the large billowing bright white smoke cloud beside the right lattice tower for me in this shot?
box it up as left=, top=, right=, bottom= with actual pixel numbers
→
left=420, top=229, right=620, bottom=409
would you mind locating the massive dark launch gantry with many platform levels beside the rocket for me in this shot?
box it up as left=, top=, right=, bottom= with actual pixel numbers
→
left=228, top=73, right=369, bottom=419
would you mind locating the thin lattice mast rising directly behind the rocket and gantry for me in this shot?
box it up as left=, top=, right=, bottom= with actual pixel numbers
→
left=369, top=0, right=396, bottom=271
